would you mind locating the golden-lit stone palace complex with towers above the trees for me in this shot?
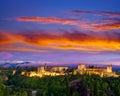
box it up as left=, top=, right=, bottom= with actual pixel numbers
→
left=21, top=64, right=119, bottom=77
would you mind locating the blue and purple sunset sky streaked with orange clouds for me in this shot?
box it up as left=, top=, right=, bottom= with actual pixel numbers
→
left=0, top=0, right=120, bottom=65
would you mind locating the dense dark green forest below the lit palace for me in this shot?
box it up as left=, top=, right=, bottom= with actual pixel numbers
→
left=0, top=68, right=120, bottom=96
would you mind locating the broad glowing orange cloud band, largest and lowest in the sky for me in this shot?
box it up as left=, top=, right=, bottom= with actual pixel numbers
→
left=0, top=30, right=120, bottom=52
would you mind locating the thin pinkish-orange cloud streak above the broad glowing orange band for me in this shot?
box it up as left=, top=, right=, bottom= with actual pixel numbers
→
left=15, top=16, right=120, bottom=32
